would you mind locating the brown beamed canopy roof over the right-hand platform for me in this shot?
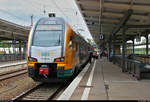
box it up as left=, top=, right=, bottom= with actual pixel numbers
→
left=76, top=0, right=150, bottom=44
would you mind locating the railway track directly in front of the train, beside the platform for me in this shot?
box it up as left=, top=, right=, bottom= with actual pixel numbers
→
left=12, top=83, right=63, bottom=101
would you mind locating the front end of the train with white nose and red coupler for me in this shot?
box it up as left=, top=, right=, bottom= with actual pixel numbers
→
left=27, top=18, right=66, bottom=82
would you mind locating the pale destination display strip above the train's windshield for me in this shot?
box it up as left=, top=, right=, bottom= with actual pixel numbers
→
left=36, top=24, right=62, bottom=30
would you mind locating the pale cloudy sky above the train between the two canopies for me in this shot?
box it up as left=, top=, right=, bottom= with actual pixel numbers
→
left=0, top=0, right=92, bottom=39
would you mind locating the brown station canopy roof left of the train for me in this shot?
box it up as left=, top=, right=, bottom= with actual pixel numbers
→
left=0, top=19, right=30, bottom=41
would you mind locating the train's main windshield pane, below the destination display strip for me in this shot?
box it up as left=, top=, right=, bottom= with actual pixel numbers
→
left=33, top=31, right=62, bottom=47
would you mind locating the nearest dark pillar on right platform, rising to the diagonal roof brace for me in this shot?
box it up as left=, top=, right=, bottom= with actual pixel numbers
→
left=122, top=28, right=126, bottom=72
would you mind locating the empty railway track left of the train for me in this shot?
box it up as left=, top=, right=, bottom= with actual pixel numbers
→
left=0, top=68, right=27, bottom=81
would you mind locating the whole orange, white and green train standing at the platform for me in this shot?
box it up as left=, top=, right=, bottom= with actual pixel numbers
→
left=27, top=17, right=93, bottom=82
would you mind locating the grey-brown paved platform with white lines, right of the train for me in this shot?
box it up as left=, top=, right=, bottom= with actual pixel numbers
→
left=57, top=57, right=150, bottom=100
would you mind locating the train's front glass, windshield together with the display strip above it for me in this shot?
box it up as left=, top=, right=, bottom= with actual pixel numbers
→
left=33, top=25, right=62, bottom=47
